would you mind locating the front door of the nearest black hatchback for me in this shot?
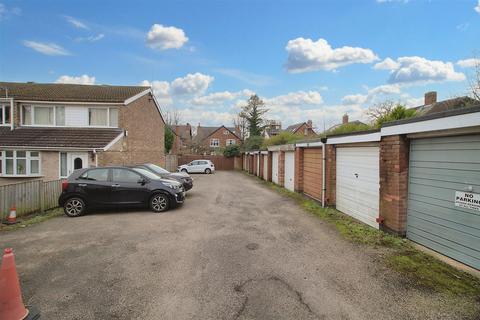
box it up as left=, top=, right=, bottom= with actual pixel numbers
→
left=111, top=168, right=149, bottom=205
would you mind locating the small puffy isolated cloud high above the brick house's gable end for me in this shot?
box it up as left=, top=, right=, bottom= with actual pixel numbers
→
left=147, top=24, right=188, bottom=50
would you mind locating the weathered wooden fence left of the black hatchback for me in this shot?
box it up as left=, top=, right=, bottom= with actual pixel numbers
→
left=0, top=180, right=62, bottom=220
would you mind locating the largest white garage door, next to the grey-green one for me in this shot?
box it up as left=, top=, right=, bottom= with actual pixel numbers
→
left=336, top=147, right=380, bottom=228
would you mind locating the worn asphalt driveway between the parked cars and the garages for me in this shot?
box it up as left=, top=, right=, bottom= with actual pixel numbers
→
left=0, top=172, right=472, bottom=320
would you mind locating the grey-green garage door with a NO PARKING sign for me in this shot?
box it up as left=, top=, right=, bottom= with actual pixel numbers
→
left=407, top=135, right=480, bottom=269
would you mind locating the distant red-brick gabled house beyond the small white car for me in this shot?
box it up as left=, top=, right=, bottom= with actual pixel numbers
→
left=192, top=124, right=242, bottom=154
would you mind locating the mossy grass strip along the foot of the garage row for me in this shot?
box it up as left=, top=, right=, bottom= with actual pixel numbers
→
left=248, top=174, right=480, bottom=300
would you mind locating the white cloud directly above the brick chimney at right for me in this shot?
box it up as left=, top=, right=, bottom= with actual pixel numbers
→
left=378, top=56, right=465, bottom=84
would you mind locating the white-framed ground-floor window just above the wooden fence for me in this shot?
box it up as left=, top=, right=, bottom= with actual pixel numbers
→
left=0, top=150, right=40, bottom=176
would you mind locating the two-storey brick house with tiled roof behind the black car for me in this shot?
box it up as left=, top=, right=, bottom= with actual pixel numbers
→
left=0, top=82, right=165, bottom=184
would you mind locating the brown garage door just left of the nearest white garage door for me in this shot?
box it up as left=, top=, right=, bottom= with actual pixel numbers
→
left=303, top=148, right=322, bottom=200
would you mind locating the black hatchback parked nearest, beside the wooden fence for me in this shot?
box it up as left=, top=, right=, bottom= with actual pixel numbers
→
left=58, top=167, right=185, bottom=217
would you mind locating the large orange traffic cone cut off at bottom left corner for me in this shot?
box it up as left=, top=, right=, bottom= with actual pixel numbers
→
left=0, top=248, right=34, bottom=320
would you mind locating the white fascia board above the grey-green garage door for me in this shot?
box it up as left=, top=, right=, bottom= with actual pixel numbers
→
left=381, top=112, right=480, bottom=136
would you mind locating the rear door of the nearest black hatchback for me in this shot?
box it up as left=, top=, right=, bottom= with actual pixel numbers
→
left=77, top=168, right=112, bottom=205
